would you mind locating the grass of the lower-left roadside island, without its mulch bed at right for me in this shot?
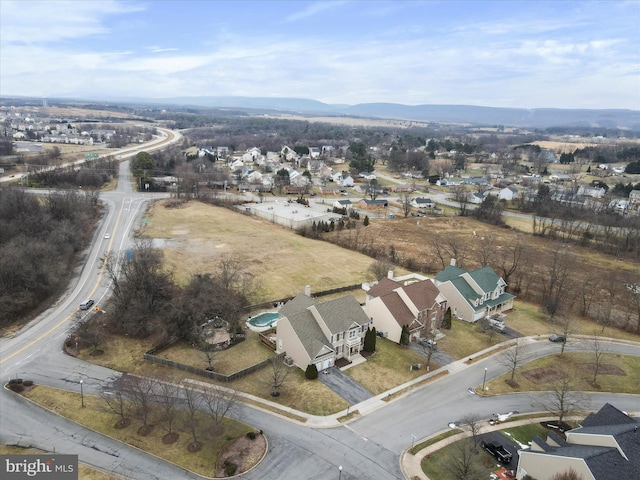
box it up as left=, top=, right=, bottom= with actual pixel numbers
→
left=25, top=386, right=254, bottom=477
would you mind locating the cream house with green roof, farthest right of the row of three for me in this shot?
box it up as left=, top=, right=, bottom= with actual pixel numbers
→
left=435, top=259, right=515, bottom=322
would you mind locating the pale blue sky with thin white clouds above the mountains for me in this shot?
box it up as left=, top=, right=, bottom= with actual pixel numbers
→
left=0, top=0, right=640, bottom=110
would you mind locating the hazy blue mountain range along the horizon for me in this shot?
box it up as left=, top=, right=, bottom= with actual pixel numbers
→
left=145, top=97, right=640, bottom=131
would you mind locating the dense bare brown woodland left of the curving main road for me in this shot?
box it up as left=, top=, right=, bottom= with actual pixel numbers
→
left=0, top=188, right=100, bottom=327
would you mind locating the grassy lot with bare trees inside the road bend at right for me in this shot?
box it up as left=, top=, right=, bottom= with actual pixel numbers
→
left=487, top=351, right=640, bottom=395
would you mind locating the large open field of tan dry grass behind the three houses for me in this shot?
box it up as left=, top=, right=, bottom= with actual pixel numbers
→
left=141, top=201, right=402, bottom=296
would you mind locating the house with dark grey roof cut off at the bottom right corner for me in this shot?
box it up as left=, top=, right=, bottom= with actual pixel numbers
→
left=516, top=403, right=640, bottom=480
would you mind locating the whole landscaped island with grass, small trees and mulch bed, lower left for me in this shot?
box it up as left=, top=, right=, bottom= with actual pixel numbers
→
left=7, top=382, right=267, bottom=478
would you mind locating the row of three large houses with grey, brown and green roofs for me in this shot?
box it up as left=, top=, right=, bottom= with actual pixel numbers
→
left=275, top=261, right=515, bottom=371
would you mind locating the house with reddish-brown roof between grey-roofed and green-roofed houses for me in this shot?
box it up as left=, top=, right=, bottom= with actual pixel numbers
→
left=365, top=278, right=447, bottom=343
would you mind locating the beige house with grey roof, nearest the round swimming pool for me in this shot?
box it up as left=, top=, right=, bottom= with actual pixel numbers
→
left=276, top=294, right=371, bottom=371
